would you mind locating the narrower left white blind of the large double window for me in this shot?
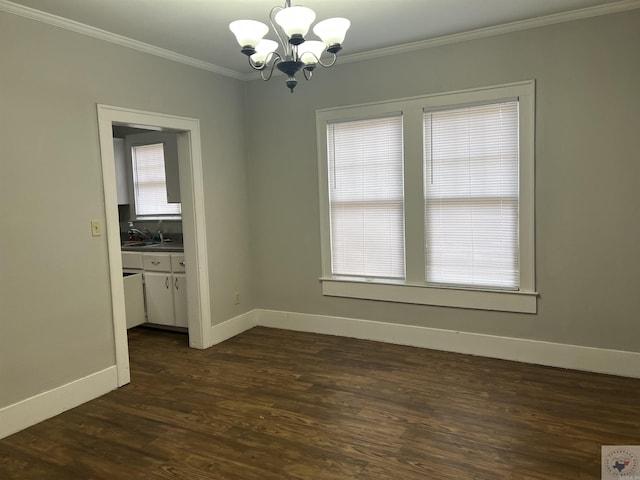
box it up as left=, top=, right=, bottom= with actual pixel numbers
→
left=327, top=115, right=405, bottom=279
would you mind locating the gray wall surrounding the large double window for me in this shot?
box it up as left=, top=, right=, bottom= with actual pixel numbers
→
left=246, top=10, right=640, bottom=352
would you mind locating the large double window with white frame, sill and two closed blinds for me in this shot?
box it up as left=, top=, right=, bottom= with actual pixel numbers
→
left=317, top=82, right=537, bottom=313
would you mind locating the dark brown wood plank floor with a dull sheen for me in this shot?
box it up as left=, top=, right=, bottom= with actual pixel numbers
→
left=0, top=328, right=640, bottom=480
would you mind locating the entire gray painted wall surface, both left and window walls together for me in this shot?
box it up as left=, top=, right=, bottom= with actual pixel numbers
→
left=0, top=4, right=640, bottom=408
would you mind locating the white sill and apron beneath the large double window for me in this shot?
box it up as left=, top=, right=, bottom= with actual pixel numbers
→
left=320, top=278, right=538, bottom=313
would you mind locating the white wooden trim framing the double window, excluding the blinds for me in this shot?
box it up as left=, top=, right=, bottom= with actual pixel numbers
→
left=316, top=80, right=538, bottom=313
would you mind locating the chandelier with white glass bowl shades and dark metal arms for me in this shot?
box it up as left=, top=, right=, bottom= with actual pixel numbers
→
left=229, top=0, right=351, bottom=93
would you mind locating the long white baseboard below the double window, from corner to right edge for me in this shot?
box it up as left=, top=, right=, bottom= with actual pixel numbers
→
left=254, top=310, right=640, bottom=378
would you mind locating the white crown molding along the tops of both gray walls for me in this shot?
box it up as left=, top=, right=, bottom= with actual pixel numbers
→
left=0, top=0, right=640, bottom=80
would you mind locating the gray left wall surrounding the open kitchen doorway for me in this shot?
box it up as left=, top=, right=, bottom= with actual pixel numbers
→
left=0, top=12, right=253, bottom=407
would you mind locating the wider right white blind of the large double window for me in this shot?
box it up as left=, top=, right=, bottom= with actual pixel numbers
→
left=424, top=101, right=520, bottom=289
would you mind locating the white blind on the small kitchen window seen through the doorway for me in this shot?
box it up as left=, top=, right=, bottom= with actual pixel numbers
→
left=131, top=143, right=181, bottom=215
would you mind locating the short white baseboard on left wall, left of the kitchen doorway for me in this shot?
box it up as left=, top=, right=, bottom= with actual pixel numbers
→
left=0, top=365, right=118, bottom=438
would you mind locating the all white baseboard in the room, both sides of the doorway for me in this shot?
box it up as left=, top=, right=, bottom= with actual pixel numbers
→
left=5, top=309, right=640, bottom=438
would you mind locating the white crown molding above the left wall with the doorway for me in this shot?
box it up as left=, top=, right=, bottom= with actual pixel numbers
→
left=0, top=0, right=245, bottom=80
